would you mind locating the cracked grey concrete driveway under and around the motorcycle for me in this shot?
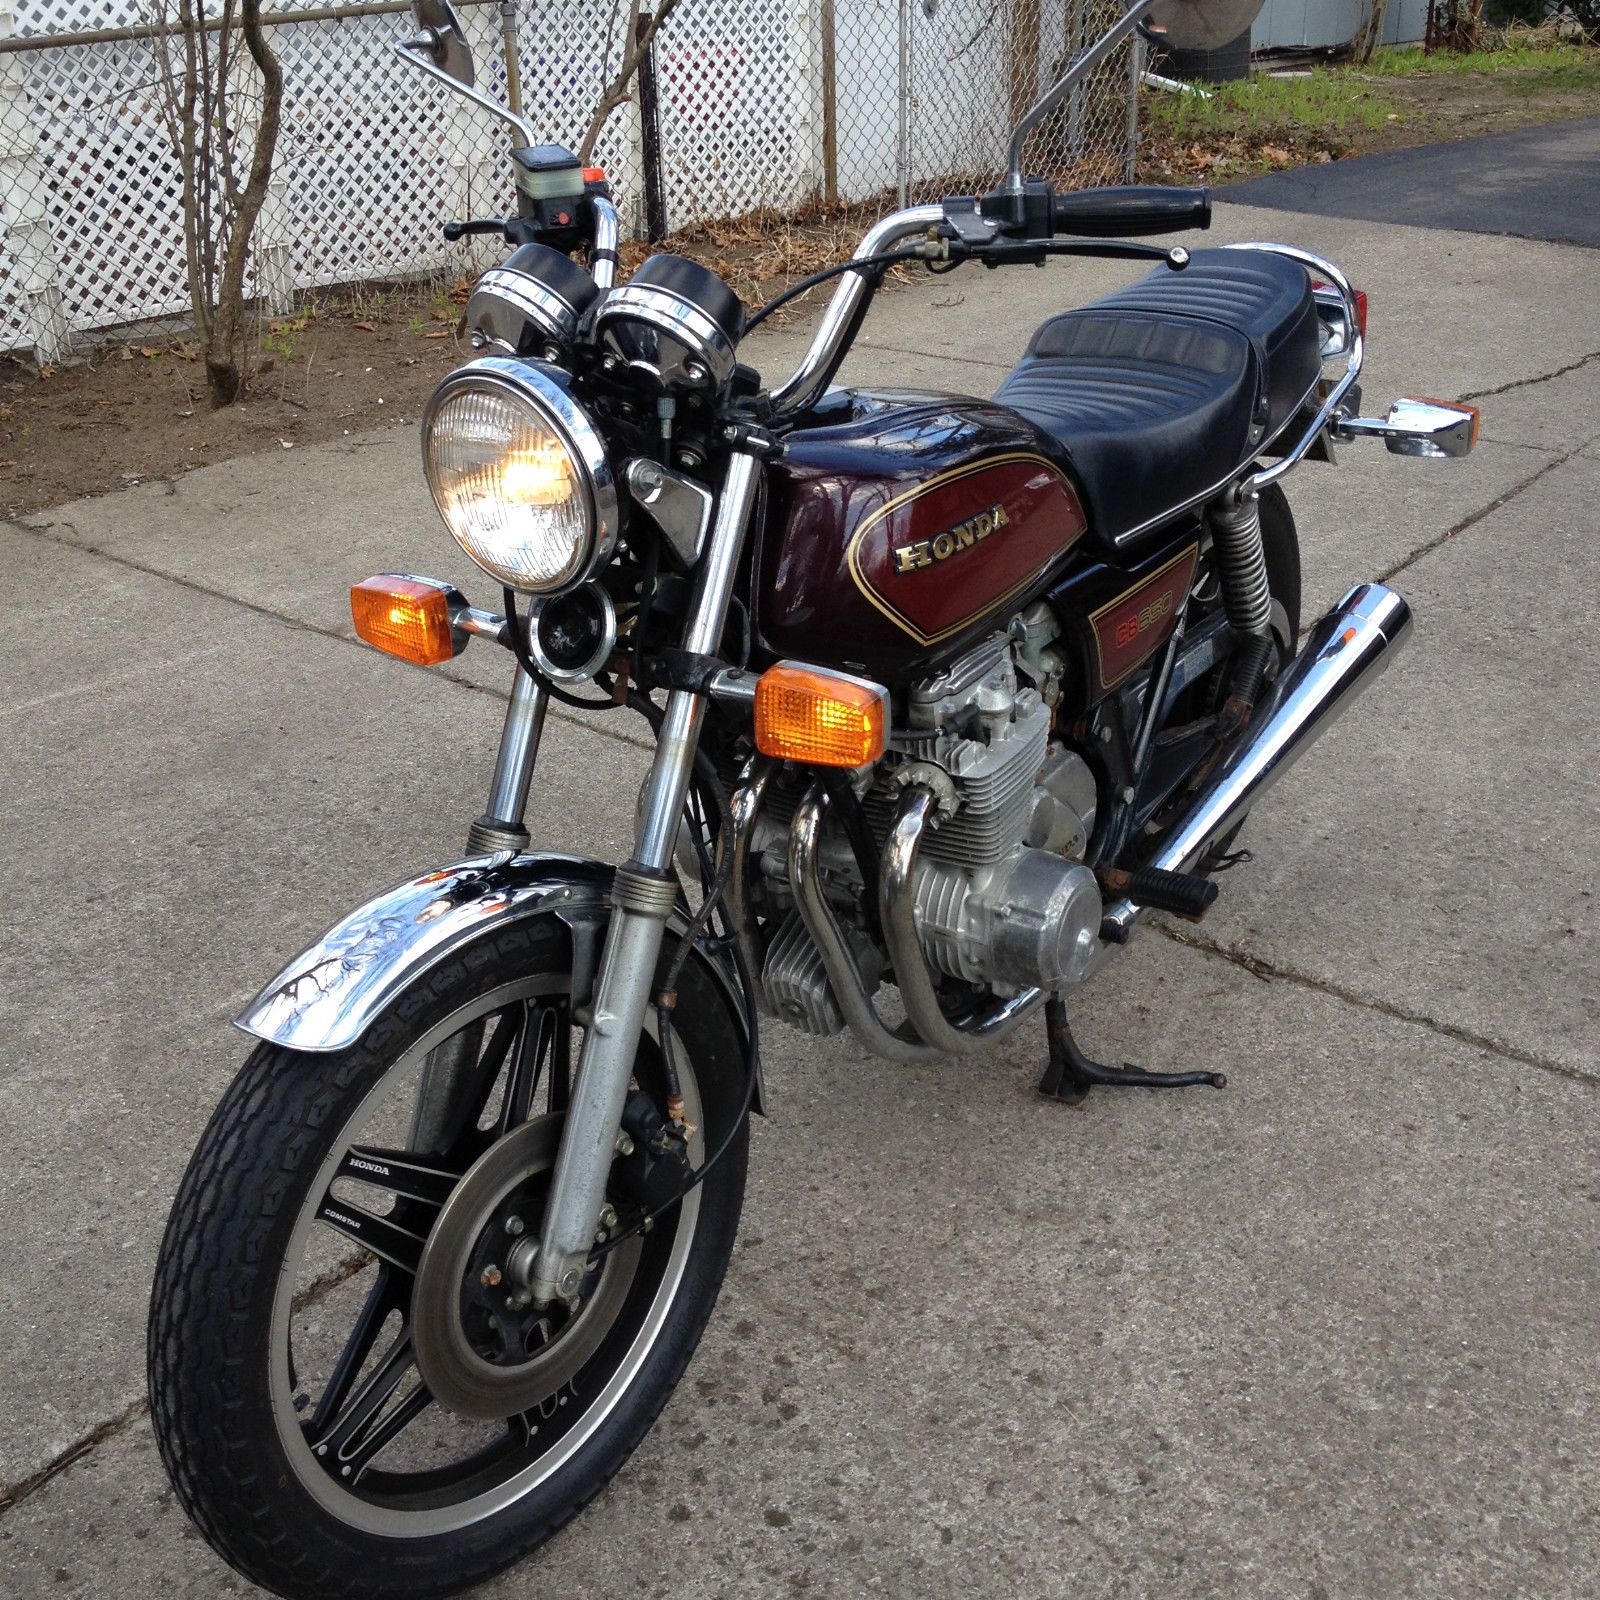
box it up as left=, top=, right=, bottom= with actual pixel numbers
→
left=0, top=193, right=1600, bottom=1600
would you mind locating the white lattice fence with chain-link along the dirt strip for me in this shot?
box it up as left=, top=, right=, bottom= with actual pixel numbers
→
left=0, top=0, right=1134, bottom=357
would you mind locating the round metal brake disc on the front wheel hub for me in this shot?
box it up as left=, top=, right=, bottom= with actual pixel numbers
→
left=411, top=1112, right=643, bottom=1421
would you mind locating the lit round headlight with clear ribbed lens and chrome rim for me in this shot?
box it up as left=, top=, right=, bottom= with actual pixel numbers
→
left=422, top=357, right=618, bottom=594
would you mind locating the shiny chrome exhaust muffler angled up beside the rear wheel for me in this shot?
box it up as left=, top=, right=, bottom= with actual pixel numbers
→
left=1101, top=584, right=1411, bottom=944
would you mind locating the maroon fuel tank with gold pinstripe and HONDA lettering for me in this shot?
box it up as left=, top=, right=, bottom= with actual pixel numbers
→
left=752, top=392, right=1086, bottom=682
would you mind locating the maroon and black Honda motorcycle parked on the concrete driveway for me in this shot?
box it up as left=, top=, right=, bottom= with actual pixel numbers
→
left=149, top=0, right=1477, bottom=1597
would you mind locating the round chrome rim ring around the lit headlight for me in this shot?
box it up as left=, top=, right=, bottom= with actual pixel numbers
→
left=422, top=355, right=621, bottom=595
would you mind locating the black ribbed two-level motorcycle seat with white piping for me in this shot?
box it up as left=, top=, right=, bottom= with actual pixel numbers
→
left=995, top=250, right=1322, bottom=544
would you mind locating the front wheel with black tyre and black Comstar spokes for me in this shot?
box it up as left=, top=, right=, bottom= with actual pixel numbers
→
left=149, top=920, right=746, bottom=1600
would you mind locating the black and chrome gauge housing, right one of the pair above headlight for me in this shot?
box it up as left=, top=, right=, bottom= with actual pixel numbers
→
left=594, top=256, right=744, bottom=392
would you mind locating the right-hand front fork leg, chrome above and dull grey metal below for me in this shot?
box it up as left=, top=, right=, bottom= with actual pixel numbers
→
left=528, top=451, right=760, bottom=1306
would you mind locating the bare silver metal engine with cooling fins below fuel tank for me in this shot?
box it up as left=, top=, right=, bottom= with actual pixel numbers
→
left=752, top=635, right=1101, bottom=1034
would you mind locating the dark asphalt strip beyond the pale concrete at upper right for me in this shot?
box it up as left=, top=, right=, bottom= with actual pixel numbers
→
left=1218, top=117, right=1600, bottom=246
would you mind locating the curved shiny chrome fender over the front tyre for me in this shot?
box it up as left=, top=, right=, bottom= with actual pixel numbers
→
left=234, top=851, right=760, bottom=1109
